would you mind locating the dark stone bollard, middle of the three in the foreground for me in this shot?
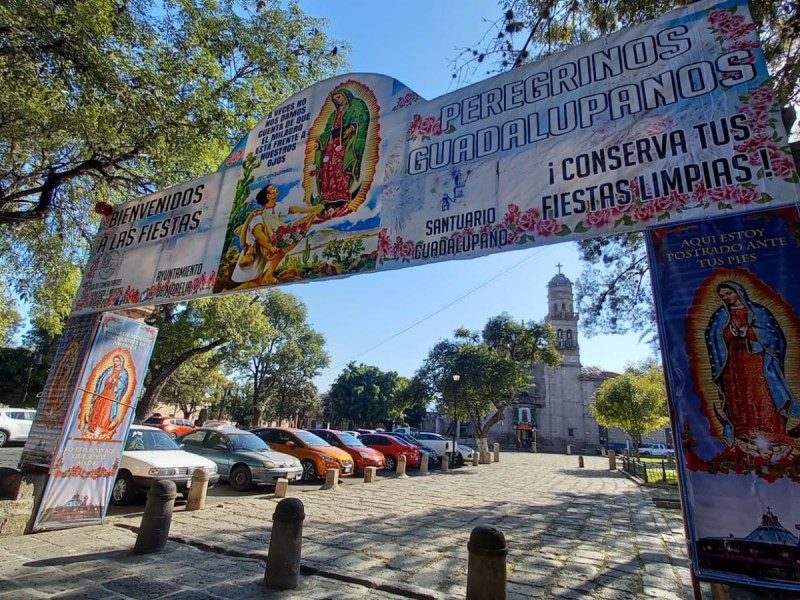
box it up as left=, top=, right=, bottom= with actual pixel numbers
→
left=264, top=498, right=306, bottom=590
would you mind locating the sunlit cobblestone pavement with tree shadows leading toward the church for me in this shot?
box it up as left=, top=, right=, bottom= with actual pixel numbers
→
left=0, top=452, right=710, bottom=600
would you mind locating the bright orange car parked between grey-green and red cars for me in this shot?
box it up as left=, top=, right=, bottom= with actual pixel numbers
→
left=252, top=427, right=353, bottom=481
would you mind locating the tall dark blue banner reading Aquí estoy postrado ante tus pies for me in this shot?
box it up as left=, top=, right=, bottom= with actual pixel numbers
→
left=647, top=206, right=800, bottom=591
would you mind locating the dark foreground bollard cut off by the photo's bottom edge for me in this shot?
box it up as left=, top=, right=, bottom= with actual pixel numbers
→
left=467, top=525, right=508, bottom=600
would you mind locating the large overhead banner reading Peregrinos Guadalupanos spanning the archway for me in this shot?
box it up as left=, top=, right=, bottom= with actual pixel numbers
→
left=74, top=0, right=800, bottom=314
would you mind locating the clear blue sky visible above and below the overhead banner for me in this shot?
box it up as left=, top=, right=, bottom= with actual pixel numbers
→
left=281, top=0, right=650, bottom=391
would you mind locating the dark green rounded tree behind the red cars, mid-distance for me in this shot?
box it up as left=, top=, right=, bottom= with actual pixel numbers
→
left=326, top=362, right=408, bottom=427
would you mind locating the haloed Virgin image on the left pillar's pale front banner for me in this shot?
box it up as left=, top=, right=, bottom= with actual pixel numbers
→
left=78, top=353, right=130, bottom=439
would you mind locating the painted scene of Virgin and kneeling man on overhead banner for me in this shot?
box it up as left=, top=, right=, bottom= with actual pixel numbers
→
left=214, top=79, right=380, bottom=292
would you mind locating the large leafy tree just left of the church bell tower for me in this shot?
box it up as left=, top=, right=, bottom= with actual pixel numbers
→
left=415, top=314, right=561, bottom=451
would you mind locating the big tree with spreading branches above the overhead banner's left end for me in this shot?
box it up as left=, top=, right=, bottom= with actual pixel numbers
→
left=0, top=0, right=347, bottom=331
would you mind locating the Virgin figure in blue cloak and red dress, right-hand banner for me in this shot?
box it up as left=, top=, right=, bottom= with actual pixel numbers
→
left=705, top=280, right=800, bottom=446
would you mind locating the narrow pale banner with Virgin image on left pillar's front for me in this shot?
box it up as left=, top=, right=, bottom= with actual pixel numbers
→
left=33, top=313, right=157, bottom=531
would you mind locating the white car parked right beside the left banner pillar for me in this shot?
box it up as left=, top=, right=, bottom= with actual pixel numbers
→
left=111, top=425, right=219, bottom=504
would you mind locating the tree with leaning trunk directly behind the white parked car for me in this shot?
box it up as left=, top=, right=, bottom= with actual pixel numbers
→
left=136, top=294, right=267, bottom=421
